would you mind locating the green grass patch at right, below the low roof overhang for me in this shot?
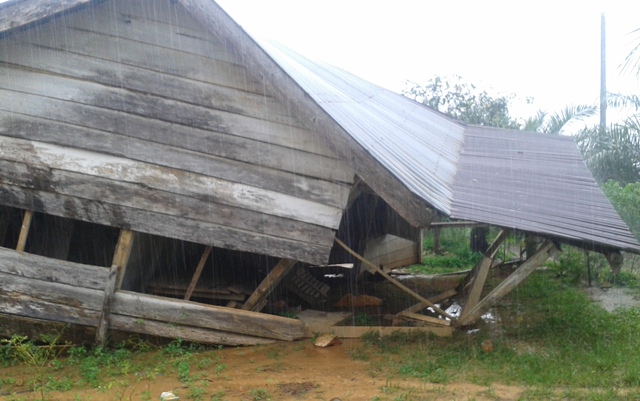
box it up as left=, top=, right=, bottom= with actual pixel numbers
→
left=363, top=272, right=640, bottom=388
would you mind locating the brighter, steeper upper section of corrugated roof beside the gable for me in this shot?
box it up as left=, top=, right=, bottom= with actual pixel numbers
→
left=261, top=42, right=464, bottom=214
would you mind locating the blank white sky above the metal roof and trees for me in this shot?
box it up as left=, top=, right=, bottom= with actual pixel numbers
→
left=218, top=0, right=640, bottom=119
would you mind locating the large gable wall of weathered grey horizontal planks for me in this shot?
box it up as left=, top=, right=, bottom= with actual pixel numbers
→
left=0, top=0, right=353, bottom=263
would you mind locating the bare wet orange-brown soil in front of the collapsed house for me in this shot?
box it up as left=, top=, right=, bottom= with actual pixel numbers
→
left=0, top=340, right=524, bottom=401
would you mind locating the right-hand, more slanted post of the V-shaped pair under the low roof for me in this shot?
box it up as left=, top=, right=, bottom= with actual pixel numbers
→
left=458, top=240, right=559, bottom=326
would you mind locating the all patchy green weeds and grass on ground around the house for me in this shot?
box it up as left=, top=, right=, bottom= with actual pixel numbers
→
left=0, top=229, right=640, bottom=401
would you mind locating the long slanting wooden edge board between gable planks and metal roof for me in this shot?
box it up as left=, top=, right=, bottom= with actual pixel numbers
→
left=178, top=0, right=432, bottom=227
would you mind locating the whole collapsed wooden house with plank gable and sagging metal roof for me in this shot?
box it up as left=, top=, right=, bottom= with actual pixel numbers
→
left=0, top=0, right=640, bottom=344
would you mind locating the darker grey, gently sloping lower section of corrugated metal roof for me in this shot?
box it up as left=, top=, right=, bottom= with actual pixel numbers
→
left=451, top=127, right=640, bottom=251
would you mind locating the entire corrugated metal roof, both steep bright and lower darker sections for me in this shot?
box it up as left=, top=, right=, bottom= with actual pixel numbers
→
left=261, top=43, right=640, bottom=252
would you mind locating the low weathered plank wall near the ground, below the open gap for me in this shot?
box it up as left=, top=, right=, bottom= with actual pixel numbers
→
left=0, top=247, right=304, bottom=345
